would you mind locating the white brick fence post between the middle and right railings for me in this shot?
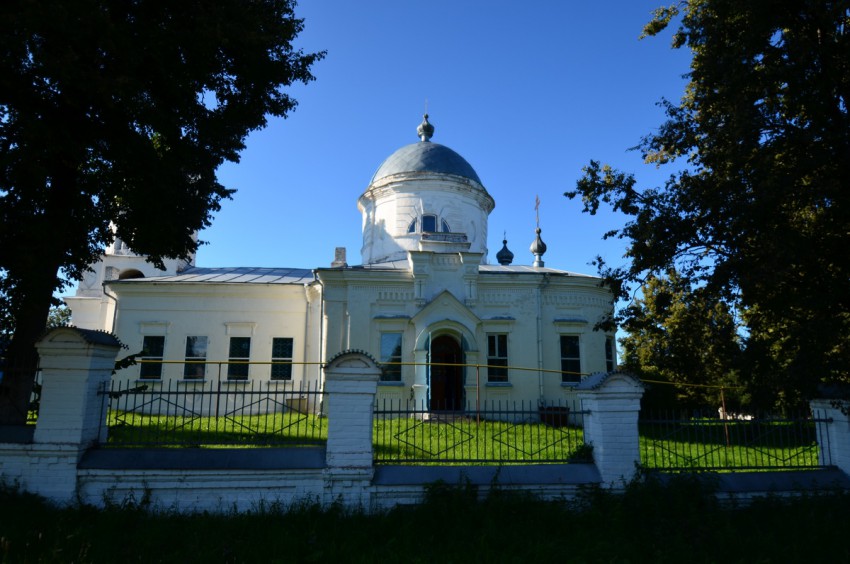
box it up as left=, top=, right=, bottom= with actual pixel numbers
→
left=576, top=372, right=643, bottom=484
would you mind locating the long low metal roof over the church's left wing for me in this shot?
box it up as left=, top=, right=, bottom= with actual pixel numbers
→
left=109, top=267, right=314, bottom=284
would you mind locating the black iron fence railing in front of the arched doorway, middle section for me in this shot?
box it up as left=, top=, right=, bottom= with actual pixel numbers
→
left=373, top=399, right=591, bottom=464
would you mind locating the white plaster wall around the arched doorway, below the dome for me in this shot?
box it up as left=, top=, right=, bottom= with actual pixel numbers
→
left=319, top=252, right=611, bottom=408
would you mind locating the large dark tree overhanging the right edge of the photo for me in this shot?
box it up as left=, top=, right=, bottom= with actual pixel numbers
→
left=566, top=0, right=850, bottom=408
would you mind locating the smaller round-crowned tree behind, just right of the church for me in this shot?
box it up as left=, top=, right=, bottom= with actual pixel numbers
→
left=621, top=270, right=741, bottom=407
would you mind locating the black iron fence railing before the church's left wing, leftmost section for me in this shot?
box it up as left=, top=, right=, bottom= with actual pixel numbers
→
left=98, top=380, right=327, bottom=447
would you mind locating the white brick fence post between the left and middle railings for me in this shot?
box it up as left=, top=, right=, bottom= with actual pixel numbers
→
left=324, top=351, right=381, bottom=505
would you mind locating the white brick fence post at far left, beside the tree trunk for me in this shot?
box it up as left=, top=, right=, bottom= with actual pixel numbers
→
left=23, top=327, right=121, bottom=502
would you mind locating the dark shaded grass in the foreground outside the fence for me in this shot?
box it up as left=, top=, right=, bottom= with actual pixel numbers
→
left=0, top=476, right=850, bottom=564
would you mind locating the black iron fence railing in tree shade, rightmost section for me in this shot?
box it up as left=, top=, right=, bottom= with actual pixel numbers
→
left=639, top=412, right=832, bottom=471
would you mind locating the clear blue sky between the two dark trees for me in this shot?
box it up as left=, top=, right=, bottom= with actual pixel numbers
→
left=196, top=0, right=690, bottom=274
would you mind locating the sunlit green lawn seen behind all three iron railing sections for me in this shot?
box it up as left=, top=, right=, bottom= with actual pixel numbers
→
left=101, top=411, right=818, bottom=470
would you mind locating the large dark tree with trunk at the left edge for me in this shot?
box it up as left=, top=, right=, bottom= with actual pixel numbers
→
left=0, top=0, right=323, bottom=422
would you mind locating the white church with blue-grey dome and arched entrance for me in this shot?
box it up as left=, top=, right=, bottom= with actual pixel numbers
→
left=65, top=115, right=616, bottom=410
